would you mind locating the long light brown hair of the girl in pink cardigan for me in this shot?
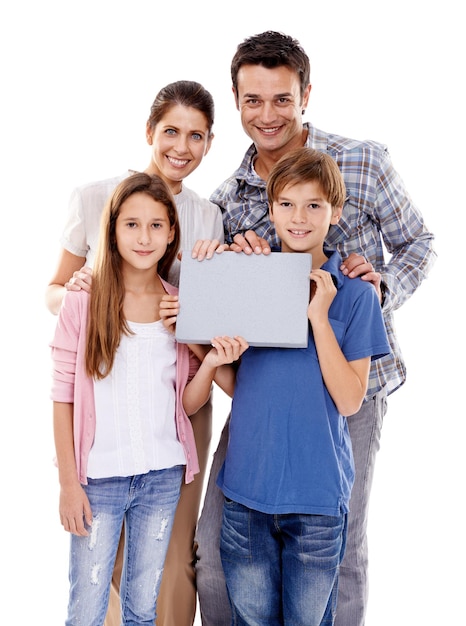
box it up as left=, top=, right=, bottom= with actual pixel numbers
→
left=86, top=173, right=180, bottom=380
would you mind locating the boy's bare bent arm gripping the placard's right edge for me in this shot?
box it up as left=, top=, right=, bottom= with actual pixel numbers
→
left=308, top=269, right=371, bottom=415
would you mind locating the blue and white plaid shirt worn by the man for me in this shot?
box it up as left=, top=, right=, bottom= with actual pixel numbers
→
left=210, top=123, right=436, bottom=397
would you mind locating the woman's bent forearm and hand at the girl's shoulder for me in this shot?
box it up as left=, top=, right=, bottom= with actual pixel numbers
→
left=45, top=248, right=92, bottom=315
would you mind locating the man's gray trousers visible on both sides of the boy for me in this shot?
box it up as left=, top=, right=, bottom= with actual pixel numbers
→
left=196, top=390, right=387, bottom=626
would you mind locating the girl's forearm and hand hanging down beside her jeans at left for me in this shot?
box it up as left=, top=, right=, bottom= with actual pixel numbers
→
left=53, top=402, right=92, bottom=537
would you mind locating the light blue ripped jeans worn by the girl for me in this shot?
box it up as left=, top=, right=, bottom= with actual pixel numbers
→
left=66, top=465, right=184, bottom=626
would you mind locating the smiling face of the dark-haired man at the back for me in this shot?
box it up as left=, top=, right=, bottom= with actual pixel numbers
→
left=235, top=65, right=311, bottom=156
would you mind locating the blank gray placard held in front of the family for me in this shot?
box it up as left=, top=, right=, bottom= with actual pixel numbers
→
left=176, top=250, right=312, bottom=348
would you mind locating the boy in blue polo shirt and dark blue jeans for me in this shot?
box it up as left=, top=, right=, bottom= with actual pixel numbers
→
left=217, top=148, right=390, bottom=626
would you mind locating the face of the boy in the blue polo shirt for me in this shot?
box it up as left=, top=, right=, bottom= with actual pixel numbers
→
left=270, top=181, right=342, bottom=268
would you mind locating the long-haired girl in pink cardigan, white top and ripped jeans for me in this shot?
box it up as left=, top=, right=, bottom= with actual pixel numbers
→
left=51, top=173, right=244, bottom=626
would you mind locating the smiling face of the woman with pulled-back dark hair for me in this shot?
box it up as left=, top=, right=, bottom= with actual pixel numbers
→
left=146, top=104, right=213, bottom=194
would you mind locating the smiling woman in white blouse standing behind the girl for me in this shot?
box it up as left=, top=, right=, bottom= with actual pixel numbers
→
left=46, top=81, right=223, bottom=626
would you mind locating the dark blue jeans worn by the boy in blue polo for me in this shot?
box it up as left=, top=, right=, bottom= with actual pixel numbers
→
left=220, top=499, right=346, bottom=626
